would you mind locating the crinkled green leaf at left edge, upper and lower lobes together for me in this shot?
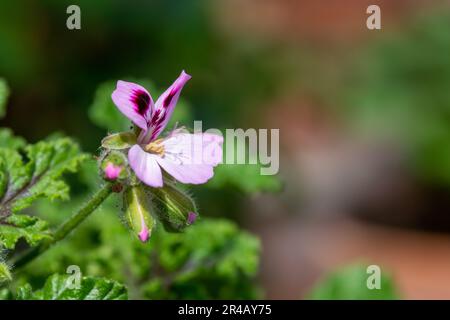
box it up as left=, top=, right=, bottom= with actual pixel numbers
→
left=0, top=138, right=86, bottom=249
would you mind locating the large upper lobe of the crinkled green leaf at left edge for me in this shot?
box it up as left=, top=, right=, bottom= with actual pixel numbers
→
left=0, top=138, right=87, bottom=217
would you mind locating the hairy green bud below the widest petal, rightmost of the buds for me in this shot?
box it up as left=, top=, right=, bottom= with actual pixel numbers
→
left=152, top=183, right=198, bottom=232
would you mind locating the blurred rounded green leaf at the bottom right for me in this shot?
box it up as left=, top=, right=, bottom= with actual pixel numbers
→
left=309, top=264, right=398, bottom=300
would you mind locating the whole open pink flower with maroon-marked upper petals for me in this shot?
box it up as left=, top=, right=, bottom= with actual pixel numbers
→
left=112, top=71, right=223, bottom=187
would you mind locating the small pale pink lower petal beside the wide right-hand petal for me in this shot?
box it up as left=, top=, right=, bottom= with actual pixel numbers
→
left=128, top=145, right=163, bottom=188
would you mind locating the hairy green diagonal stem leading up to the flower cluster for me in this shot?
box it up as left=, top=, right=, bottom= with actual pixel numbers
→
left=11, top=182, right=112, bottom=270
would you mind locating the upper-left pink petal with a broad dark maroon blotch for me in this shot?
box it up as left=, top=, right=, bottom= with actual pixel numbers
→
left=111, top=80, right=154, bottom=130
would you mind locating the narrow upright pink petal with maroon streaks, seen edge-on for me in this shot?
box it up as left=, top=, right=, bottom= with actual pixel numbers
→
left=144, top=71, right=191, bottom=143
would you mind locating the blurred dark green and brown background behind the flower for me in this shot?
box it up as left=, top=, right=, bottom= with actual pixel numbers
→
left=0, top=0, right=450, bottom=299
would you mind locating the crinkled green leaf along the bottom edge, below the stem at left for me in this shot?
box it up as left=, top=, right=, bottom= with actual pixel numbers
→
left=17, top=274, right=128, bottom=300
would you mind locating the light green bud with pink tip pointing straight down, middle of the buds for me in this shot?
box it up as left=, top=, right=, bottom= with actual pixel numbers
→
left=123, top=185, right=155, bottom=242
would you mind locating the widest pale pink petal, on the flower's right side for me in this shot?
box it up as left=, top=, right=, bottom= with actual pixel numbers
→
left=157, top=133, right=223, bottom=184
